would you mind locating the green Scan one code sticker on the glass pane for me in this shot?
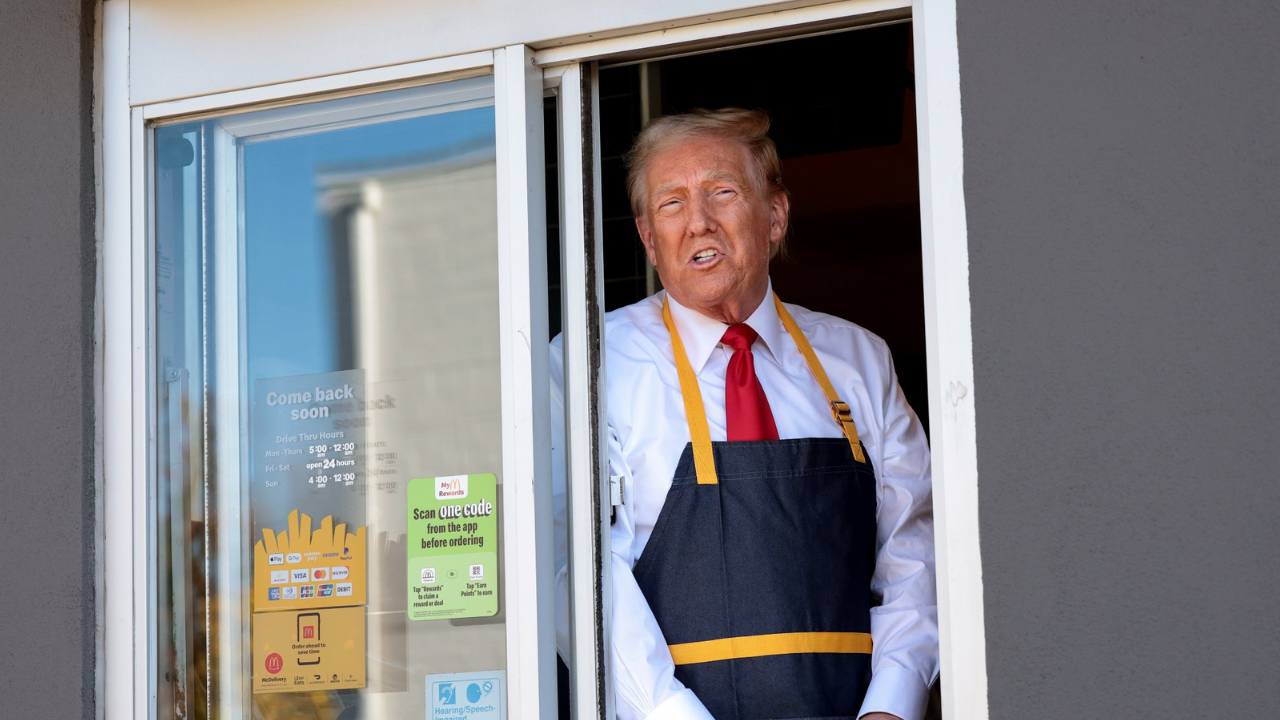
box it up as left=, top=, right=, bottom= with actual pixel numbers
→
left=407, top=473, right=498, bottom=620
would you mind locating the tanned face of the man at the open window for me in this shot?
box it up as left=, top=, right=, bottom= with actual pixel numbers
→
left=636, top=138, right=790, bottom=323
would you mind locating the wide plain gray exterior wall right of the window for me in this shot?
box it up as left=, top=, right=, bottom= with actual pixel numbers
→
left=959, top=0, right=1280, bottom=720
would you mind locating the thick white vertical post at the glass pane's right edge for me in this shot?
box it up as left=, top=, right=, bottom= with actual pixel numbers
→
left=494, top=45, right=556, bottom=717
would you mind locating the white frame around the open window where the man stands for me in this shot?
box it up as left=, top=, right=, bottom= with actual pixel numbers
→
left=545, top=0, right=987, bottom=720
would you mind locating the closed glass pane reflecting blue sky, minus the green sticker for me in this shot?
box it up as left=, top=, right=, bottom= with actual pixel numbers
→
left=154, top=78, right=506, bottom=720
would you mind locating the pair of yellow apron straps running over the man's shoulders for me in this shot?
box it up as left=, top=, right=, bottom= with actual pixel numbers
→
left=662, top=293, right=867, bottom=486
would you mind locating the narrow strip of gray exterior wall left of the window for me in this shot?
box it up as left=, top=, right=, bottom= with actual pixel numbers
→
left=0, top=0, right=95, bottom=717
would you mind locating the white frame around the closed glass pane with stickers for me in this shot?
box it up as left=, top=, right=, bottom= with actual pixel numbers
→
left=100, top=30, right=556, bottom=720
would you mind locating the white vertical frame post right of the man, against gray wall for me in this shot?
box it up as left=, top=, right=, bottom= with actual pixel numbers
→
left=911, top=0, right=988, bottom=720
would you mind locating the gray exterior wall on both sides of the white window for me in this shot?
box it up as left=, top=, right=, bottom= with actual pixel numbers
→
left=0, top=0, right=1280, bottom=720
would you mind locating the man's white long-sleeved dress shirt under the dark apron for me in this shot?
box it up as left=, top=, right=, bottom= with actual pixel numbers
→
left=552, top=283, right=938, bottom=720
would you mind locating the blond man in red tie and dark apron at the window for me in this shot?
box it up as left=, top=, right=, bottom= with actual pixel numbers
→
left=553, top=109, right=937, bottom=720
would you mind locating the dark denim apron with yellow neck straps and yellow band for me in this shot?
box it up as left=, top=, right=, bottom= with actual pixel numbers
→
left=634, top=296, right=876, bottom=720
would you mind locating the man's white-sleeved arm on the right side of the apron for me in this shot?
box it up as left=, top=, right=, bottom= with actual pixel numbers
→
left=861, top=340, right=938, bottom=720
